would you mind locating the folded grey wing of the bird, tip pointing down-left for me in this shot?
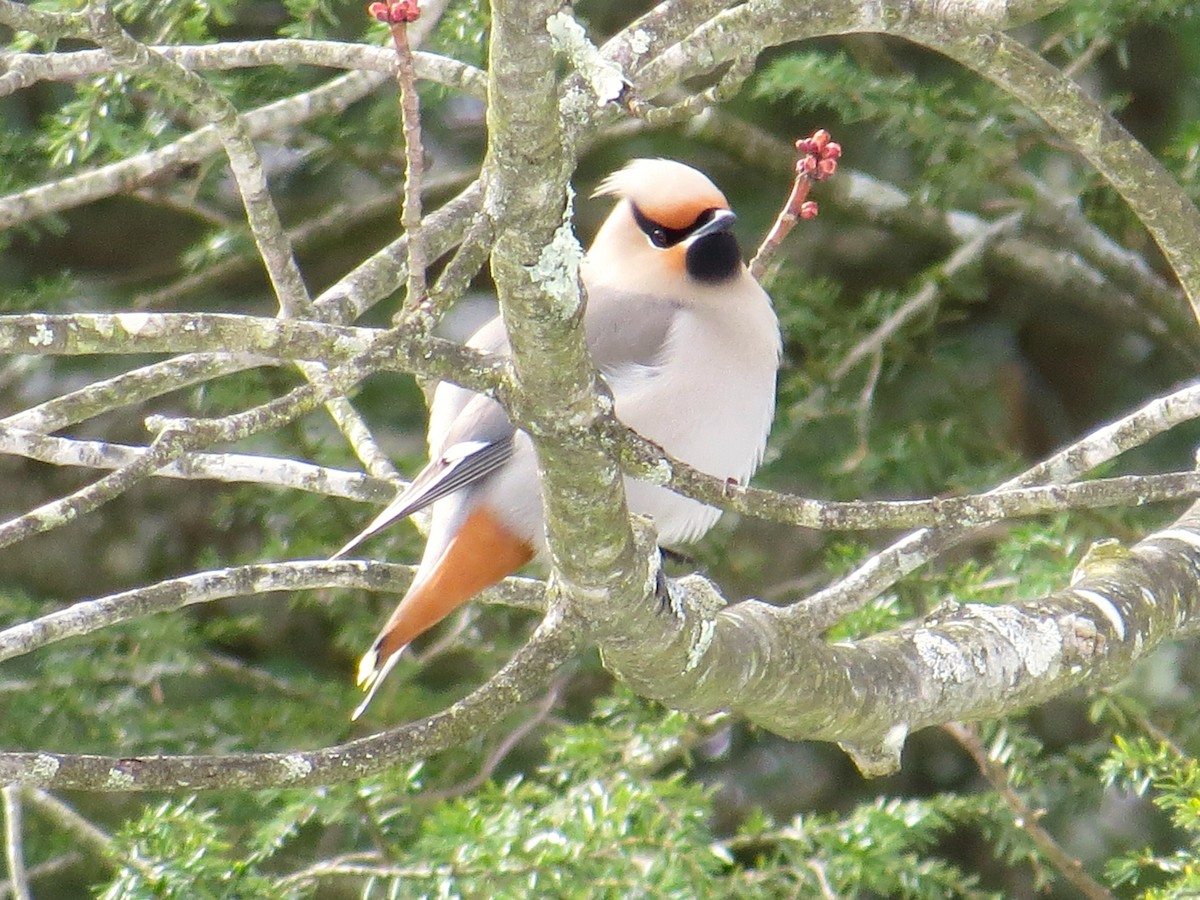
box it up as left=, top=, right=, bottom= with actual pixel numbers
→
left=330, top=394, right=515, bottom=559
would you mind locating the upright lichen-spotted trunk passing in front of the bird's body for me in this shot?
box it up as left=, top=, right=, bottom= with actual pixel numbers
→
left=482, top=0, right=650, bottom=635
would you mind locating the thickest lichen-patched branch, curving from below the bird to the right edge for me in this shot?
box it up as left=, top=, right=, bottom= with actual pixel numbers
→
left=606, top=508, right=1200, bottom=774
